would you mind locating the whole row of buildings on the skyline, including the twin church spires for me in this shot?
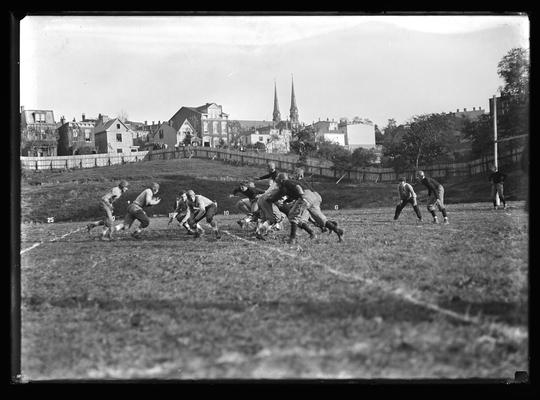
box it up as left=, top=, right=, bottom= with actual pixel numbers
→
left=21, top=76, right=375, bottom=156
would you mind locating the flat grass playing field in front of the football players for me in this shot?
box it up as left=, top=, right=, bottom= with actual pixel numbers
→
left=21, top=202, right=528, bottom=380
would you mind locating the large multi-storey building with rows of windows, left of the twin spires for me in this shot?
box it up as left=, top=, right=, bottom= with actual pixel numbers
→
left=169, top=103, right=229, bottom=147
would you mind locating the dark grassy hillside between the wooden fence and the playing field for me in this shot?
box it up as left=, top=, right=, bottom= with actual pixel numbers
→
left=21, top=159, right=527, bottom=222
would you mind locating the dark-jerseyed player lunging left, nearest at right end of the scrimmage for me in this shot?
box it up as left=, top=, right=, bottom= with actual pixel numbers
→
left=266, top=173, right=343, bottom=244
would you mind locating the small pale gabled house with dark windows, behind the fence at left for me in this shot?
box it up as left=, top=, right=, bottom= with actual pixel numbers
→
left=94, top=118, right=138, bottom=154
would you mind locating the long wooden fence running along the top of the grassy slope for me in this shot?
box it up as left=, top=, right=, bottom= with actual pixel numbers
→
left=21, top=147, right=523, bottom=182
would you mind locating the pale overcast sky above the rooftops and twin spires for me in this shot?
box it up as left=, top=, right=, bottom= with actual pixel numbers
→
left=20, top=16, right=529, bottom=130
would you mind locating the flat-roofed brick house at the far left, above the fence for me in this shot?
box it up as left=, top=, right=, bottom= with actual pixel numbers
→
left=20, top=107, right=58, bottom=157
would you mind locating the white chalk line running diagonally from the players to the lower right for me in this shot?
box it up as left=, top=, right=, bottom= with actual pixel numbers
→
left=222, top=230, right=528, bottom=339
